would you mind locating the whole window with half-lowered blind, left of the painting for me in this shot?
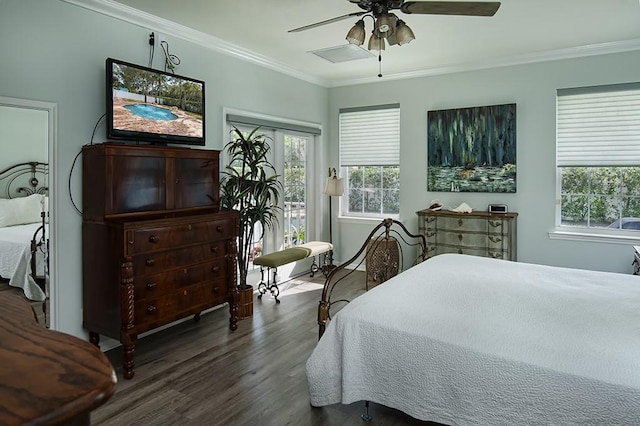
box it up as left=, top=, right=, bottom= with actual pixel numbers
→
left=339, top=104, right=400, bottom=218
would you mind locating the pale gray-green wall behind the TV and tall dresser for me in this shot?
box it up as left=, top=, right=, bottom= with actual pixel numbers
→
left=0, top=0, right=328, bottom=336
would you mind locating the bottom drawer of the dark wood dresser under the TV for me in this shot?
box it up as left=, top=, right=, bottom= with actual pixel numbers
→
left=134, top=283, right=228, bottom=331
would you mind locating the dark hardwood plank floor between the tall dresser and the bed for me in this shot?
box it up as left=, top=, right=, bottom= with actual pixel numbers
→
left=92, top=274, right=438, bottom=426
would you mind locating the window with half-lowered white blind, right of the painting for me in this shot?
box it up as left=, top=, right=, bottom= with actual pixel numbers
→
left=556, top=84, right=640, bottom=230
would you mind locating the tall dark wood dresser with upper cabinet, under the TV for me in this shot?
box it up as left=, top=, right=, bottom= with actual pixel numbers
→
left=82, top=144, right=238, bottom=379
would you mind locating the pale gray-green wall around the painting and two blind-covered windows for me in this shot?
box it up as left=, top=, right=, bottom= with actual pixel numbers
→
left=328, top=52, right=640, bottom=273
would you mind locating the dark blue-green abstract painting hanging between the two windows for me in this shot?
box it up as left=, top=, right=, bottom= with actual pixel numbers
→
left=427, top=104, right=516, bottom=192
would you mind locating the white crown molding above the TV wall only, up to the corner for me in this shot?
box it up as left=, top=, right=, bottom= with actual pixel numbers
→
left=61, top=0, right=329, bottom=87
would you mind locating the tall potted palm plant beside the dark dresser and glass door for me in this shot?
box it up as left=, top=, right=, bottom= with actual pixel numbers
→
left=220, top=126, right=282, bottom=318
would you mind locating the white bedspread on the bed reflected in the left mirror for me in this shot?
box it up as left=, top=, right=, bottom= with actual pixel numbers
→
left=0, top=223, right=48, bottom=301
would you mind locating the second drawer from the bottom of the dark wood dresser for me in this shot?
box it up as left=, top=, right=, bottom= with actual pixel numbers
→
left=133, top=259, right=227, bottom=300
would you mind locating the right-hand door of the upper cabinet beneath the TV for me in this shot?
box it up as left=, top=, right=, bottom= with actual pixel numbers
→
left=169, top=153, right=220, bottom=209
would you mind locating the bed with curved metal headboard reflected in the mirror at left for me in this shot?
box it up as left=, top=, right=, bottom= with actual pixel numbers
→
left=0, top=162, right=49, bottom=301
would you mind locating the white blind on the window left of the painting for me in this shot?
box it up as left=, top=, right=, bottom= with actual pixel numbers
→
left=339, top=104, right=400, bottom=167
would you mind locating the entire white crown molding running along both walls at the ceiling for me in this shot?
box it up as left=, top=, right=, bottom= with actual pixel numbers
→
left=61, top=0, right=640, bottom=87
